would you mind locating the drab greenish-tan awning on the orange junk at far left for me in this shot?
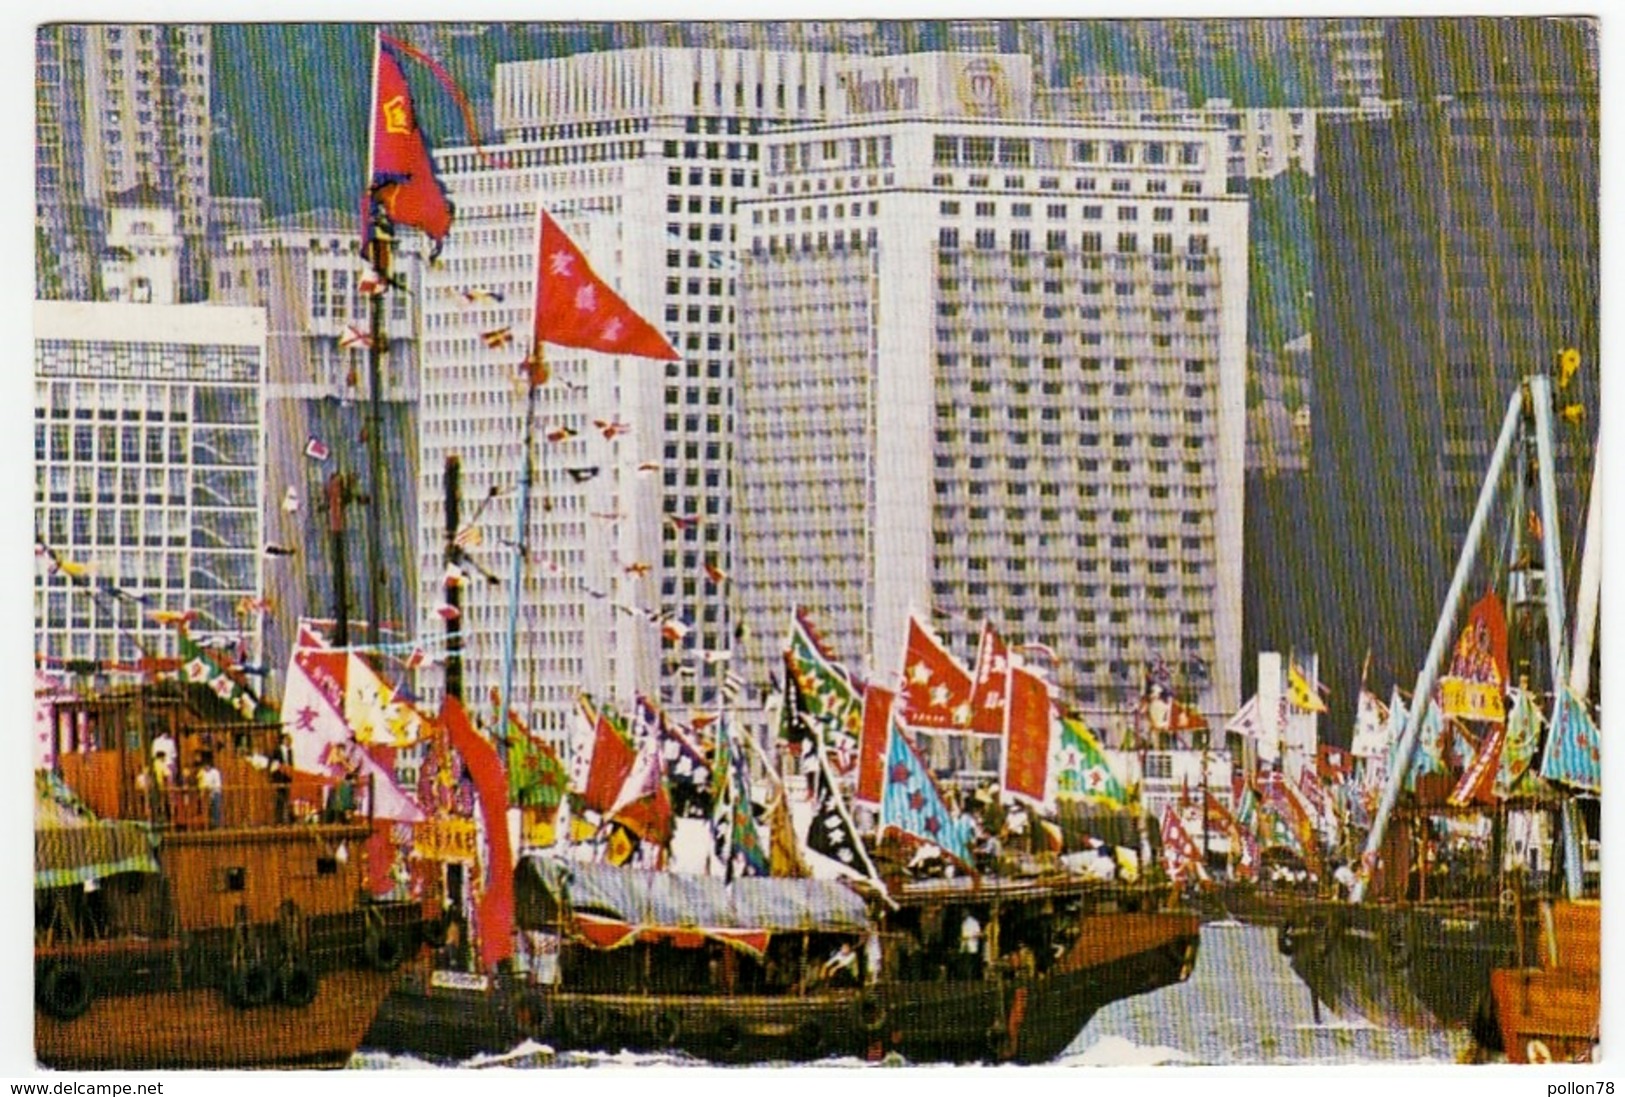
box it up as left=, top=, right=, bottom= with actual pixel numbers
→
left=34, top=774, right=158, bottom=887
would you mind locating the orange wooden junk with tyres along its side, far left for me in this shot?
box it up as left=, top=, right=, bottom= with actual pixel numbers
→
left=34, top=686, right=423, bottom=1069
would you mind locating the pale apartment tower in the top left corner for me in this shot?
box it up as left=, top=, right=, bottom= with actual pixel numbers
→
left=34, top=23, right=211, bottom=301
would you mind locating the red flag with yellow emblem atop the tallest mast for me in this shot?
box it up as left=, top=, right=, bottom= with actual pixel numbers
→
left=361, top=39, right=452, bottom=250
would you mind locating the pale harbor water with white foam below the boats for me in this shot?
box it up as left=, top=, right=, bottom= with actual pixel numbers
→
left=351, top=921, right=1471, bottom=1069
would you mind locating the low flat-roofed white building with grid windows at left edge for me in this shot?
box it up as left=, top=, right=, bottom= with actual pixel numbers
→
left=34, top=301, right=265, bottom=670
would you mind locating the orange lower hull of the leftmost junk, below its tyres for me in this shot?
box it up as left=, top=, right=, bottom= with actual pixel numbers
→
left=34, top=969, right=398, bottom=1069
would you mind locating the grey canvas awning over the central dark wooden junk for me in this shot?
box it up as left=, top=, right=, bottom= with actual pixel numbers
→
left=520, top=853, right=869, bottom=947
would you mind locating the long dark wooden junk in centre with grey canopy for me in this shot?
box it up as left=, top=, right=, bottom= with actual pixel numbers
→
left=366, top=853, right=1199, bottom=1063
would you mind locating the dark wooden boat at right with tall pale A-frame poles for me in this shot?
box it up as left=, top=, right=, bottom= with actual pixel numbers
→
left=1279, top=375, right=1597, bottom=1056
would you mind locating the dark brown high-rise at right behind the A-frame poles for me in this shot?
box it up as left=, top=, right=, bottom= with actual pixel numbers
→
left=1310, top=20, right=1601, bottom=725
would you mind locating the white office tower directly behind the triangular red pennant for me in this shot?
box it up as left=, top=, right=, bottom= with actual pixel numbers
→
left=419, top=49, right=832, bottom=736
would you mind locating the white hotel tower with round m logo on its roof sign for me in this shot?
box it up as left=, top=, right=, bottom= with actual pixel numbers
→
left=736, top=54, right=1246, bottom=733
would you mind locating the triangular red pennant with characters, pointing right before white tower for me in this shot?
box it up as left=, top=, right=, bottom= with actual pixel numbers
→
left=536, top=210, right=683, bottom=361
